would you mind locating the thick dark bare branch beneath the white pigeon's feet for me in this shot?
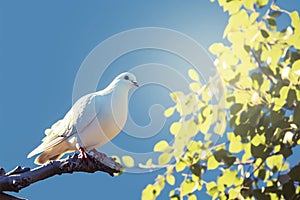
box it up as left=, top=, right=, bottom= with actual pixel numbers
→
left=0, top=154, right=123, bottom=200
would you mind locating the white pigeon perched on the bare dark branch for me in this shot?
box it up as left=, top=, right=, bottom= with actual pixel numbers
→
left=27, top=72, right=138, bottom=165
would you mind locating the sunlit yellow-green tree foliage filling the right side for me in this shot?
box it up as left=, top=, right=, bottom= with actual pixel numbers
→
left=142, top=0, right=300, bottom=200
